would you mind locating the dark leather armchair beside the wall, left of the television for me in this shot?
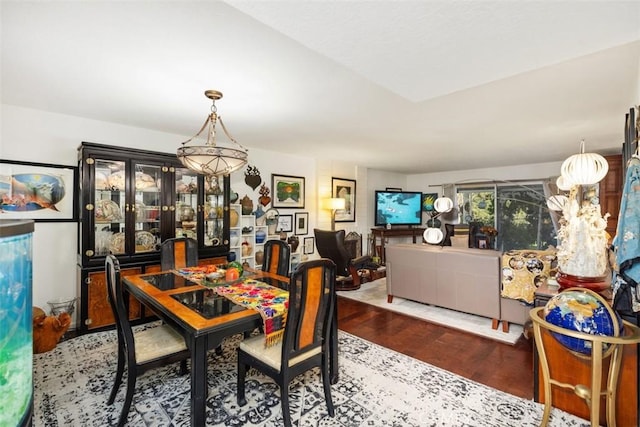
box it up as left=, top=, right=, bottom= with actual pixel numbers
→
left=313, top=228, right=372, bottom=291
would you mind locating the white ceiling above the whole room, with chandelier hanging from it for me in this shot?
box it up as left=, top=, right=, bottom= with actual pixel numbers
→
left=0, top=0, right=640, bottom=174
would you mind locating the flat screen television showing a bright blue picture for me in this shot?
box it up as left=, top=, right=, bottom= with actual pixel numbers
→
left=375, top=190, right=422, bottom=226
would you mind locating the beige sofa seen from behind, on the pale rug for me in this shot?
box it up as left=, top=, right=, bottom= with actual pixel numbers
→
left=386, top=244, right=529, bottom=331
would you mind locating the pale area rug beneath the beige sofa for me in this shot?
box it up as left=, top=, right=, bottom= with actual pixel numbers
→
left=338, top=277, right=522, bottom=344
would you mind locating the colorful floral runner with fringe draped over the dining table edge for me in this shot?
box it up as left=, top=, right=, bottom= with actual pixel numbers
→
left=213, top=279, right=289, bottom=347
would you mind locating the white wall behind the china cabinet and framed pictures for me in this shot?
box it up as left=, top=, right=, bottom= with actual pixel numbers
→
left=0, top=104, right=317, bottom=328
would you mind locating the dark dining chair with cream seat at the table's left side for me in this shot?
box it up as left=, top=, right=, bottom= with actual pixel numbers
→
left=105, top=255, right=190, bottom=426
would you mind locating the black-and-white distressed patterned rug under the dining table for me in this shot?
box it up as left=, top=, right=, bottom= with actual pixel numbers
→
left=34, top=331, right=588, bottom=427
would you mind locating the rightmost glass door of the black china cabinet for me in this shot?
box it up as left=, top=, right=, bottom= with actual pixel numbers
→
left=202, top=176, right=225, bottom=247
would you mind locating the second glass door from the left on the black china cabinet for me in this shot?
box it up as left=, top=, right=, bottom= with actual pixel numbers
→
left=130, top=163, right=162, bottom=253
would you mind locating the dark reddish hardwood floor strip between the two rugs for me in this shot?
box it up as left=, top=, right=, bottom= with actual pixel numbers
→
left=338, top=297, right=533, bottom=399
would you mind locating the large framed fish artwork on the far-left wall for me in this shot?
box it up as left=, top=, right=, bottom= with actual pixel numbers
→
left=0, top=159, right=78, bottom=222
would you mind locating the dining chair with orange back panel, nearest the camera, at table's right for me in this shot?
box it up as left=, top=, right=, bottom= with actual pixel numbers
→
left=237, top=258, right=336, bottom=427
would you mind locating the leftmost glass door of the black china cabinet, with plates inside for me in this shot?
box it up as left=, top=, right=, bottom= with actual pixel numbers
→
left=94, top=159, right=126, bottom=256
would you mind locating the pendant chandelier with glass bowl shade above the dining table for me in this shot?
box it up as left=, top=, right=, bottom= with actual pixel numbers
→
left=177, top=90, right=249, bottom=176
